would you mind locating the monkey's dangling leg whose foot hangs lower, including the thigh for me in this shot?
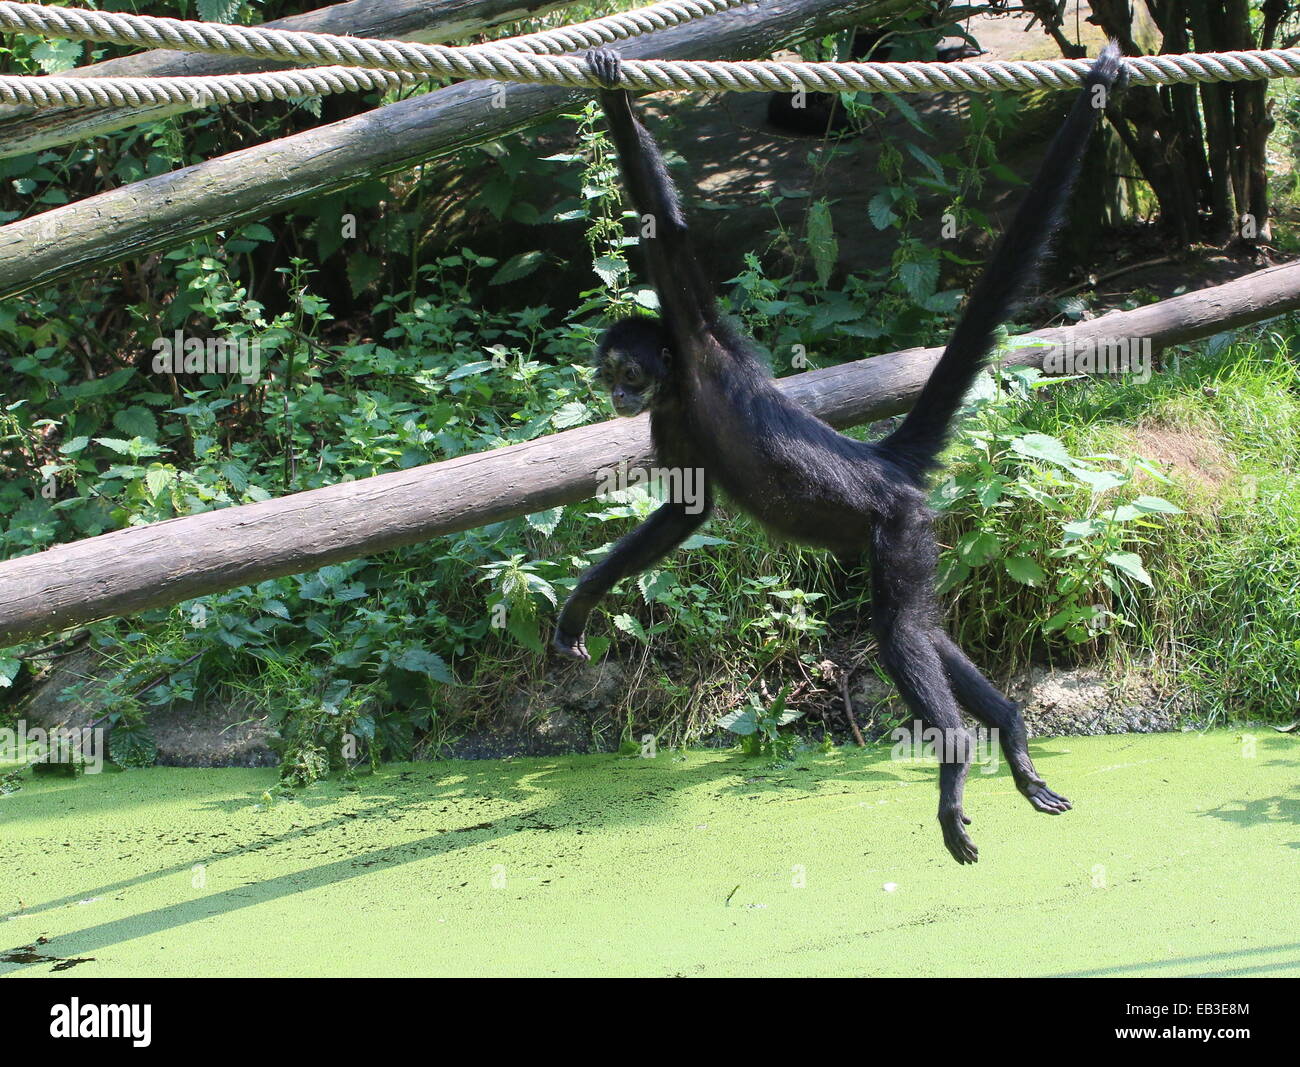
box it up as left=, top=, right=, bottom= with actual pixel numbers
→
left=871, top=507, right=979, bottom=863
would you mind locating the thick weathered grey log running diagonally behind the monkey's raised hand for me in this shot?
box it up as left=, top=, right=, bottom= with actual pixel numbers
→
left=0, top=0, right=914, bottom=299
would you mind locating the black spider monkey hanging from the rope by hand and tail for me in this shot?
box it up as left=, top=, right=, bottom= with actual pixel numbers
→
left=553, top=44, right=1123, bottom=863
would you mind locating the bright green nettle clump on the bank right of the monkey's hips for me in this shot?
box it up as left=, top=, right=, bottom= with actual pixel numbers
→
left=931, top=358, right=1182, bottom=643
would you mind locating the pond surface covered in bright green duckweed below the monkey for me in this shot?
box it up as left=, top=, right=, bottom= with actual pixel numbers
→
left=0, top=728, right=1300, bottom=977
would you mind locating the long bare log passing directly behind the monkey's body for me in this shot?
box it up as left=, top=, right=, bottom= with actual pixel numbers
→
left=0, top=264, right=1300, bottom=647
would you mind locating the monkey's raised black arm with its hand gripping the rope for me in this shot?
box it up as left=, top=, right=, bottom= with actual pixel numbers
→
left=588, top=48, right=715, bottom=330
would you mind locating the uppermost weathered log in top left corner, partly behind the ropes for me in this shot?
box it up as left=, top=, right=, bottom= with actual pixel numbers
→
left=0, top=0, right=572, bottom=159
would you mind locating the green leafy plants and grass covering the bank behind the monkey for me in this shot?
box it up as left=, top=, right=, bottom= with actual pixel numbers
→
left=0, top=4, right=1300, bottom=784
